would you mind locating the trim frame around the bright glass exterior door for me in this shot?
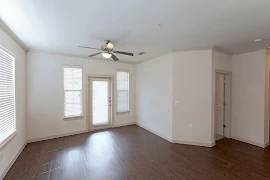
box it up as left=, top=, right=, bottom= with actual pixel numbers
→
left=86, top=74, right=115, bottom=132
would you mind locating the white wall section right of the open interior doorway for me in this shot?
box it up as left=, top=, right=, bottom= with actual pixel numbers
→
left=232, top=50, right=266, bottom=145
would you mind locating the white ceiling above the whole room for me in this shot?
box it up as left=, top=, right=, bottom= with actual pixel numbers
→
left=0, top=0, right=270, bottom=62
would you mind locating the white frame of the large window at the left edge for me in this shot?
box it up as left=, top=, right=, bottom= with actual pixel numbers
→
left=0, top=45, right=17, bottom=150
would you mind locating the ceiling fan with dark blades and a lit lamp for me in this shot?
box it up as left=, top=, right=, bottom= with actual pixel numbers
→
left=78, top=40, right=134, bottom=61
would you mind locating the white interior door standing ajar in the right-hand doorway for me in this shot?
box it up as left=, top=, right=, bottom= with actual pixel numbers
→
left=215, top=74, right=225, bottom=136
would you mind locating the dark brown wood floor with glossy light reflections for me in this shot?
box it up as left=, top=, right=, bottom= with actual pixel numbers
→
left=4, top=125, right=270, bottom=180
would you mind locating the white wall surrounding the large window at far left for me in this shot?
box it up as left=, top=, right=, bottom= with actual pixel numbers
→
left=0, top=27, right=26, bottom=179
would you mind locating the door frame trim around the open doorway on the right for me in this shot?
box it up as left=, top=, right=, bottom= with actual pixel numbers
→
left=212, top=69, right=232, bottom=143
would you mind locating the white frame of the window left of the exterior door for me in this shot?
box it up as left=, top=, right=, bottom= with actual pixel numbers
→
left=62, top=64, right=84, bottom=121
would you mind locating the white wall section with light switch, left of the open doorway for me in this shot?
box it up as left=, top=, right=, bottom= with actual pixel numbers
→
left=173, top=50, right=212, bottom=145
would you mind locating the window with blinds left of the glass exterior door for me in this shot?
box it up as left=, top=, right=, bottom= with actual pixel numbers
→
left=64, top=66, right=83, bottom=118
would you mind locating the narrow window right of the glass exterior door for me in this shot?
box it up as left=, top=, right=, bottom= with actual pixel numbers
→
left=117, top=71, right=129, bottom=112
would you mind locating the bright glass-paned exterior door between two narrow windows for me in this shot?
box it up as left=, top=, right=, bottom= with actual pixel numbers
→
left=91, top=78, right=111, bottom=127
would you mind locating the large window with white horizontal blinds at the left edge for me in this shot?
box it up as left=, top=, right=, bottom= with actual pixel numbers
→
left=0, top=48, right=16, bottom=147
